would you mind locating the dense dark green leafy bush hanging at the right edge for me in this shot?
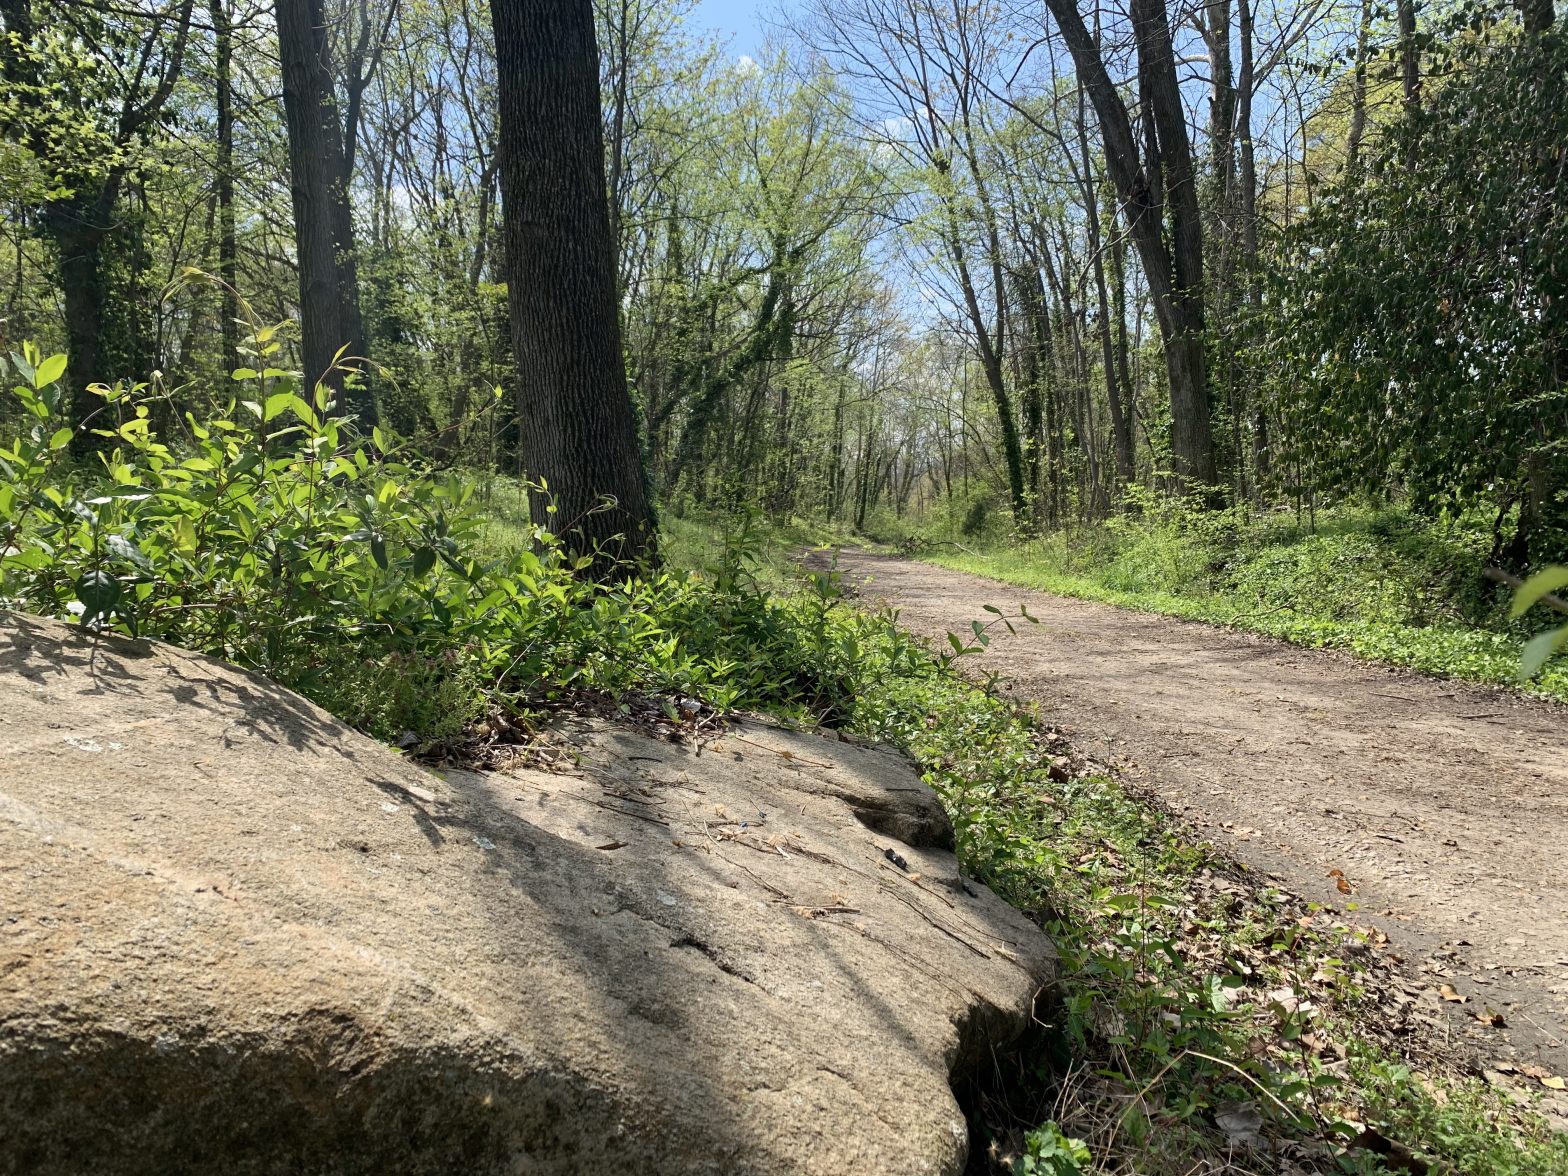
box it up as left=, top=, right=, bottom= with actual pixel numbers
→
left=1254, top=27, right=1568, bottom=563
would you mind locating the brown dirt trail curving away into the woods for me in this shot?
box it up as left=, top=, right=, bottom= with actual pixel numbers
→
left=839, top=552, right=1568, bottom=1085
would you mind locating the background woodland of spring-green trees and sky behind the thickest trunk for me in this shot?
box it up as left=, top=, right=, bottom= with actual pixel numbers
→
left=0, top=0, right=1568, bottom=571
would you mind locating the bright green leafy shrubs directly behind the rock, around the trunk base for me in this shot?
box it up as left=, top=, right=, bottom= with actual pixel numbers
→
left=0, top=344, right=896, bottom=742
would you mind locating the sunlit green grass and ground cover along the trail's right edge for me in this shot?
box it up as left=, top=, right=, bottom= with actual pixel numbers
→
left=922, top=510, right=1568, bottom=701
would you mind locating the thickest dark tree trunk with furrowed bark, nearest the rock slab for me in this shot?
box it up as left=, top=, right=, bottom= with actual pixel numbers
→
left=491, top=0, right=654, bottom=579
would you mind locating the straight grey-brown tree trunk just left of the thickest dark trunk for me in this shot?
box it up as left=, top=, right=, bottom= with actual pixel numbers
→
left=278, top=0, right=376, bottom=428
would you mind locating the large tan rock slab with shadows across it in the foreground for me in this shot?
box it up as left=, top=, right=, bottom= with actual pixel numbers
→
left=0, top=616, right=1052, bottom=1176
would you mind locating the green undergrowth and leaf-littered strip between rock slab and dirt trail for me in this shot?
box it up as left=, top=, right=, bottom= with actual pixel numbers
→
left=0, top=354, right=1568, bottom=1176
